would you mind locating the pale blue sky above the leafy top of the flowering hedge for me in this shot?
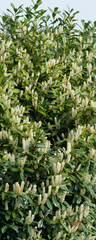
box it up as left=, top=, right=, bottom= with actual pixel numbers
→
left=0, top=0, right=96, bottom=25
